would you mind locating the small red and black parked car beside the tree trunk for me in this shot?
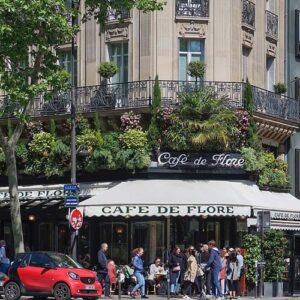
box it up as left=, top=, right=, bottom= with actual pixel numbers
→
left=4, top=252, right=102, bottom=300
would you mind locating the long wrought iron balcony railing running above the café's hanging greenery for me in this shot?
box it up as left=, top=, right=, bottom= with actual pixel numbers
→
left=0, top=80, right=300, bottom=123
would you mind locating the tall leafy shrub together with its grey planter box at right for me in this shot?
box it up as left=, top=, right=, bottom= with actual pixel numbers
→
left=262, top=230, right=287, bottom=297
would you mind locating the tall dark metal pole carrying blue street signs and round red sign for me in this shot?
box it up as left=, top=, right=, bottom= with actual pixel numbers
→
left=71, top=0, right=77, bottom=259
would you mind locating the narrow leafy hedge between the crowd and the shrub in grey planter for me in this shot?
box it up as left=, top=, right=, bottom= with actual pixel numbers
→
left=242, top=234, right=261, bottom=283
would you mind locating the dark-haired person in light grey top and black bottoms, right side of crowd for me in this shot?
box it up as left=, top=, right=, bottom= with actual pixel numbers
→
left=226, top=251, right=240, bottom=299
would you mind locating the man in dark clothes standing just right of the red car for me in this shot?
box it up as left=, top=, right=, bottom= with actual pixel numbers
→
left=97, top=243, right=110, bottom=298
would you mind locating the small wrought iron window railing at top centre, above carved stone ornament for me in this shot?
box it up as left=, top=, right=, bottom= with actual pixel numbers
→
left=176, top=0, right=209, bottom=18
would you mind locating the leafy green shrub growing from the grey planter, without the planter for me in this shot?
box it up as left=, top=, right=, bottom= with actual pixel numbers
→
left=262, top=230, right=287, bottom=282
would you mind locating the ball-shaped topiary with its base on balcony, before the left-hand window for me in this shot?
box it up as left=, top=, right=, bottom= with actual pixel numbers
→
left=95, top=61, right=119, bottom=108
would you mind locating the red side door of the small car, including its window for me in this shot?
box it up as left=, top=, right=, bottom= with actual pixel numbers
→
left=19, top=253, right=55, bottom=293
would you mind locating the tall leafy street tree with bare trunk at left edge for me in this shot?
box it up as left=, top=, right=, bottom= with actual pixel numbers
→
left=0, top=0, right=163, bottom=253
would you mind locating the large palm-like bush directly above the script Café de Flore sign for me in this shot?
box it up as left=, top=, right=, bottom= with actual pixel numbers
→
left=164, top=88, right=237, bottom=151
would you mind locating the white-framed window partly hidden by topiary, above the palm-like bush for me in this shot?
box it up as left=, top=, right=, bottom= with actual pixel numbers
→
left=179, top=39, right=204, bottom=81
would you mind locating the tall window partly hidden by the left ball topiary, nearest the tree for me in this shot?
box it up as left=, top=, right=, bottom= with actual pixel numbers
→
left=108, top=43, right=128, bottom=83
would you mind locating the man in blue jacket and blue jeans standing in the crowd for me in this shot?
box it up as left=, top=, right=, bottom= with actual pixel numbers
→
left=206, top=240, right=223, bottom=300
